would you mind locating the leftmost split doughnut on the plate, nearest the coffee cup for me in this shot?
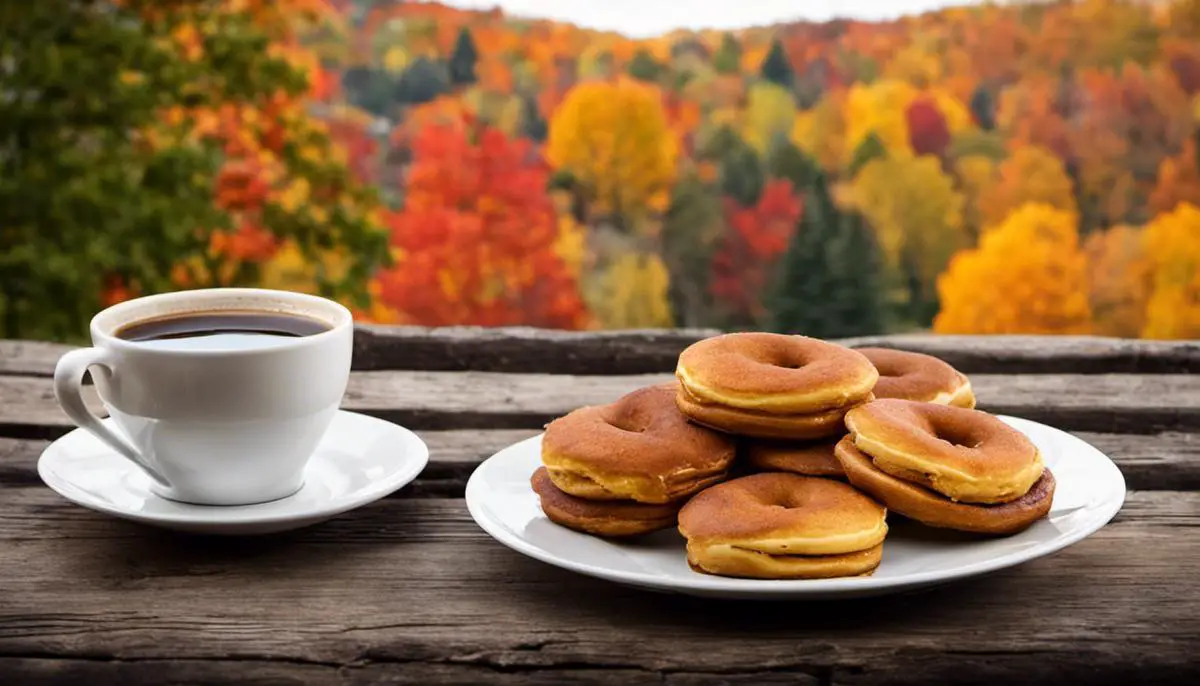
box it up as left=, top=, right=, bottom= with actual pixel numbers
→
left=530, top=384, right=734, bottom=537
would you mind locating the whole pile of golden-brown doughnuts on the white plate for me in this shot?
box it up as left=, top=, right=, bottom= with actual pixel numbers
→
left=530, top=333, right=1055, bottom=579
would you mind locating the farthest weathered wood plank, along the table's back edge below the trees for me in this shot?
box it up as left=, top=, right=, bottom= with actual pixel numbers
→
left=0, top=325, right=1200, bottom=377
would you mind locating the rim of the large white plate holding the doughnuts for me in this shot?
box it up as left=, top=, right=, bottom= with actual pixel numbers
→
left=463, top=415, right=1128, bottom=596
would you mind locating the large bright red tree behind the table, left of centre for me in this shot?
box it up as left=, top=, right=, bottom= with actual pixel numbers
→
left=377, top=121, right=586, bottom=329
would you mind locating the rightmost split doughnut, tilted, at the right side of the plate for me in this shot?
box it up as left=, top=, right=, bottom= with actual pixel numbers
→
left=835, top=399, right=1055, bottom=534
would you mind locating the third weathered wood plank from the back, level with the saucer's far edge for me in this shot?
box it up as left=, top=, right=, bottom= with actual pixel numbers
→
left=0, top=429, right=1200, bottom=498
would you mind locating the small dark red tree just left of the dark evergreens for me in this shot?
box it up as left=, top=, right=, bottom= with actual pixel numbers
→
left=709, top=180, right=802, bottom=324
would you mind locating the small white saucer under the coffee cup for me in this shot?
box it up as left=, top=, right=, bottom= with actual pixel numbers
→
left=37, top=410, right=430, bottom=535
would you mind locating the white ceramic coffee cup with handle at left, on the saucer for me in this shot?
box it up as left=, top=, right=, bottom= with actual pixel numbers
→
left=54, top=288, right=354, bottom=505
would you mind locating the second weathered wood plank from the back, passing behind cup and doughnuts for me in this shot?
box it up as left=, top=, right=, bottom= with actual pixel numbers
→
left=0, top=372, right=1200, bottom=438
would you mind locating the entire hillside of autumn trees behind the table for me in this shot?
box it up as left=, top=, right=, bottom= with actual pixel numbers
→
left=9, top=0, right=1200, bottom=337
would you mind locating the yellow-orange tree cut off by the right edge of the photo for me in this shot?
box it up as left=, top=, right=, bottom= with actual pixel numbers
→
left=1141, top=203, right=1200, bottom=338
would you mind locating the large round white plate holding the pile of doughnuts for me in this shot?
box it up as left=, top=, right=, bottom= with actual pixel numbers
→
left=467, top=416, right=1126, bottom=600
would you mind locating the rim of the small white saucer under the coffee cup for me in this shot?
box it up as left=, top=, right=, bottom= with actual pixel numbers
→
left=37, top=409, right=430, bottom=528
